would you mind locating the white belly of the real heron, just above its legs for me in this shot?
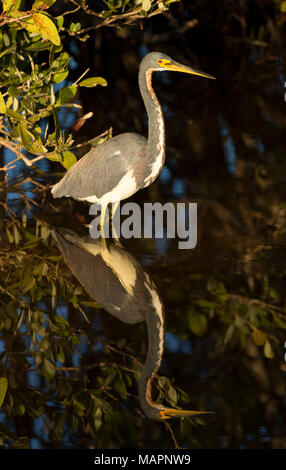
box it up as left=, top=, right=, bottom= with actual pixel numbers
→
left=79, top=170, right=138, bottom=206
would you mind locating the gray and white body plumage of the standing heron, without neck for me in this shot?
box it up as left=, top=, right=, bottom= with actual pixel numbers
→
left=52, top=133, right=147, bottom=205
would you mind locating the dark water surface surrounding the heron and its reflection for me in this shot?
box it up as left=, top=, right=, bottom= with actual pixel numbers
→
left=0, top=6, right=286, bottom=448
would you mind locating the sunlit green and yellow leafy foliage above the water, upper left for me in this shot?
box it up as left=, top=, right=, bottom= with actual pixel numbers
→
left=0, top=0, right=177, bottom=170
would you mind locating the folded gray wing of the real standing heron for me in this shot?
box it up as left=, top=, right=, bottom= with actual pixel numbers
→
left=52, top=133, right=146, bottom=199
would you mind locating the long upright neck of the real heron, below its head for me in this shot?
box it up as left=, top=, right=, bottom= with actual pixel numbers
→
left=139, top=67, right=165, bottom=184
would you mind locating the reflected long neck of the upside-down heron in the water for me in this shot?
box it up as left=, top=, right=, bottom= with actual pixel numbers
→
left=139, top=275, right=164, bottom=419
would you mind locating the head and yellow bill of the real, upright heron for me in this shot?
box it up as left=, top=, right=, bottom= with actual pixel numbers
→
left=140, top=52, right=215, bottom=79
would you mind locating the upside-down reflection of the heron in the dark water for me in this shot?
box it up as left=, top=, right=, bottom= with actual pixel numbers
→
left=53, top=230, right=212, bottom=421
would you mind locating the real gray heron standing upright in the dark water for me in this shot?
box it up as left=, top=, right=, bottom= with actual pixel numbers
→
left=52, top=52, right=214, bottom=227
